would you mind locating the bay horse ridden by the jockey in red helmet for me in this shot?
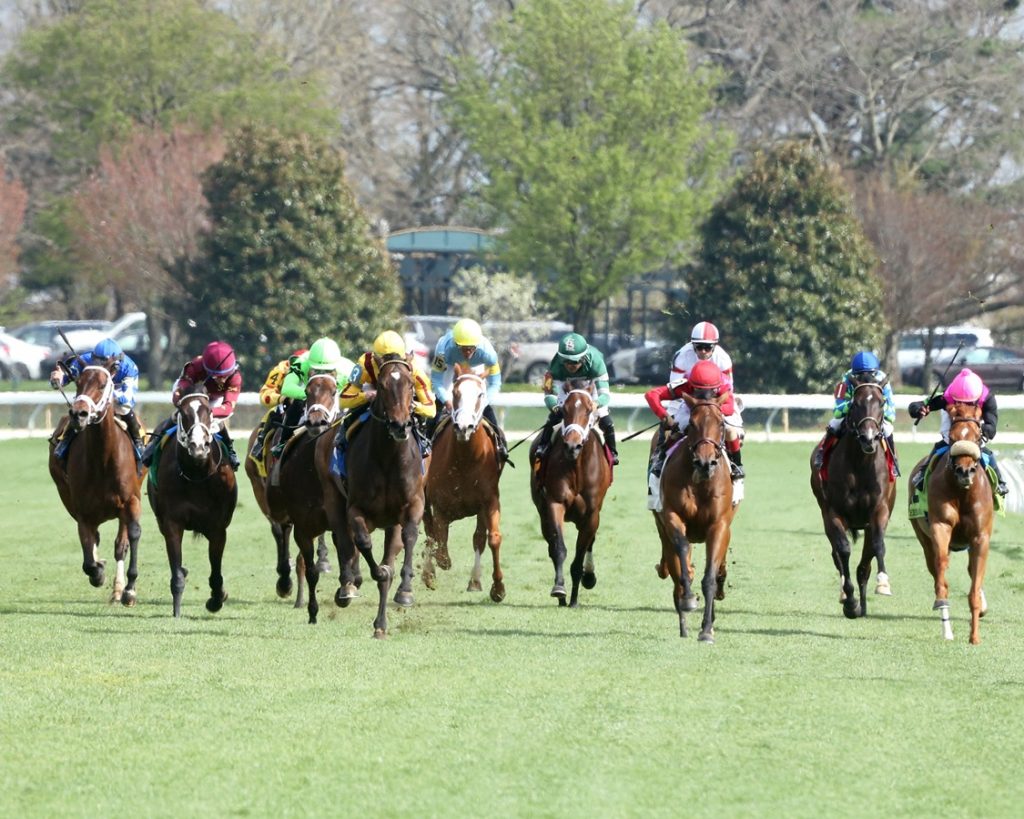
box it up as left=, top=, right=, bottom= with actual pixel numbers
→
left=652, top=393, right=736, bottom=643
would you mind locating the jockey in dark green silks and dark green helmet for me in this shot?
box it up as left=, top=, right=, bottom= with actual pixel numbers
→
left=537, top=333, right=618, bottom=465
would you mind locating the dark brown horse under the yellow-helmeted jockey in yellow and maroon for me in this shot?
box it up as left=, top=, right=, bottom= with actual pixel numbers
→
left=331, top=355, right=429, bottom=638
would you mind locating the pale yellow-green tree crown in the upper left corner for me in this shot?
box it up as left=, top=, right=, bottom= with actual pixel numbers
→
left=0, top=0, right=331, bottom=169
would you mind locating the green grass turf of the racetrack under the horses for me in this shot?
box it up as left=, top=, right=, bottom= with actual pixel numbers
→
left=0, top=440, right=1024, bottom=817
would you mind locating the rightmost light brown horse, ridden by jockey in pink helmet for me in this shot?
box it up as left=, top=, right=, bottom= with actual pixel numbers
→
left=910, top=402, right=994, bottom=645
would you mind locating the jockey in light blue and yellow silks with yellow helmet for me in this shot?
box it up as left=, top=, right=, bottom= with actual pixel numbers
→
left=428, top=318, right=509, bottom=462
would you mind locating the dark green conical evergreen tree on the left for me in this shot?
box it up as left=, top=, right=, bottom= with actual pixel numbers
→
left=190, top=128, right=401, bottom=385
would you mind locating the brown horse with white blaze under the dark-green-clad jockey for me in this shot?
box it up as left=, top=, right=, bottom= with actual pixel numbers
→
left=529, top=379, right=611, bottom=607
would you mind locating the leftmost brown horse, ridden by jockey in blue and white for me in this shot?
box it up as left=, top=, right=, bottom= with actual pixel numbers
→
left=49, top=361, right=142, bottom=606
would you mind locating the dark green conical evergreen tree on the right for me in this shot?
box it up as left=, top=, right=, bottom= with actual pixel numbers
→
left=677, top=143, right=886, bottom=392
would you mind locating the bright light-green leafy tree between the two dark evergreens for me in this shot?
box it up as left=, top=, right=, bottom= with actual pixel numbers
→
left=452, top=0, right=730, bottom=329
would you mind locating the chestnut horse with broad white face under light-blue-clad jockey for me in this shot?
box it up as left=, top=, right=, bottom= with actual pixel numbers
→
left=423, top=364, right=505, bottom=603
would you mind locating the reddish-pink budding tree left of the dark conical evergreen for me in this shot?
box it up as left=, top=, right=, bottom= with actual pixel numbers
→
left=70, top=126, right=224, bottom=387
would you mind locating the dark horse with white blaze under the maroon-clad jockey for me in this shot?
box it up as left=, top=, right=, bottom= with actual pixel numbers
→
left=150, top=385, right=239, bottom=617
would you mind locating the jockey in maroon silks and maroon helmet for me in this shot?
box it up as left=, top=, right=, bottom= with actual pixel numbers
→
left=142, top=341, right=242, bottom=470
